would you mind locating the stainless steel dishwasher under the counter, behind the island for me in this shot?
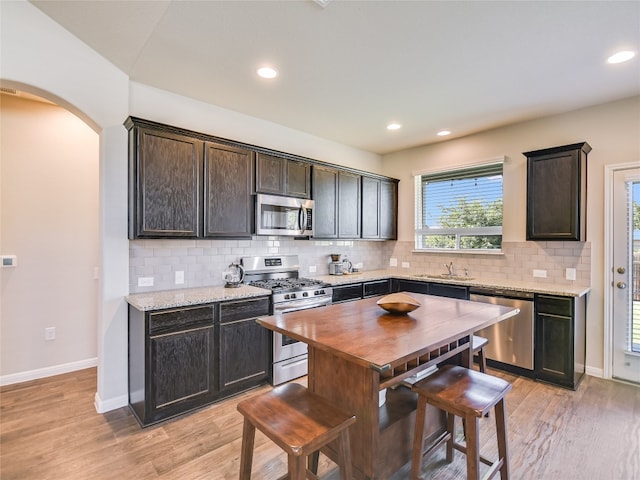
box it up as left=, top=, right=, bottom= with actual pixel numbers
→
left=469, top=287, right=534, bottom=373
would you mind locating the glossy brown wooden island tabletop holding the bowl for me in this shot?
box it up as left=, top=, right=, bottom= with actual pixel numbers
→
left=258, top=293, right=518, bottom=386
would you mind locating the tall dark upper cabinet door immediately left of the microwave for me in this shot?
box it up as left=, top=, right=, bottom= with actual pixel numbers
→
left=204, top=142, right=254, bottom=238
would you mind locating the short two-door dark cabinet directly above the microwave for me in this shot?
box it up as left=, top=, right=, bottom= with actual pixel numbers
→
left=256, top=153, right=311, bottom=198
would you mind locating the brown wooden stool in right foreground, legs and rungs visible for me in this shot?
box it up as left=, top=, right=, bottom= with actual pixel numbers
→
left=411, top=365, right=511, bottom=480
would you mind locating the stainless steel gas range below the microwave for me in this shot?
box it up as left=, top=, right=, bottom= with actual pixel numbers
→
left=241, top=255, right=333, bottom=385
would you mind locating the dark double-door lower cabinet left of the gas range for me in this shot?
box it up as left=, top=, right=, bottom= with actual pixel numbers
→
left=129, top=297, right=271, bottom=426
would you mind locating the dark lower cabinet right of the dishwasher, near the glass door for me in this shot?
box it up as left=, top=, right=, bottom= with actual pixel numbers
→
left=534, top=295, right=586, bottom=390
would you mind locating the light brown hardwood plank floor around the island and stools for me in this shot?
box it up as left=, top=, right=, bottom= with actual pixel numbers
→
left=0, top=369, right=640, bottom=480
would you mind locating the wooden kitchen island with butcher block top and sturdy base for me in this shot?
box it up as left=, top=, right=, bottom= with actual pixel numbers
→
left=257, top=293, right=518, bottom=480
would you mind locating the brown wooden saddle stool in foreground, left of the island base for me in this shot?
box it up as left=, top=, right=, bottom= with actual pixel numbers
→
left=238, top=383, right=356, bottom=480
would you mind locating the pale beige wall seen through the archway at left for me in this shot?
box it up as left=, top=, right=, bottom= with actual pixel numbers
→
left=0, top=95, right=99, bottom=383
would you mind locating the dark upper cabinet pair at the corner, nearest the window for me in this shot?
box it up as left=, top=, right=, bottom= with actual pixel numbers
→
left=362, top=176, right=398, bottom=240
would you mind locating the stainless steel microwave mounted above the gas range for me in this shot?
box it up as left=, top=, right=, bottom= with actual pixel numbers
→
left=256, top=193, right=314, bottom=237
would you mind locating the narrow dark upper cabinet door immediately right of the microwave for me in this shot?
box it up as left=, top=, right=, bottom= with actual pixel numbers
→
left=313, top=165, right=339, bottom=238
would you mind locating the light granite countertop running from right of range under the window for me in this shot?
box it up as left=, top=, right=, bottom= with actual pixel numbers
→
left=314, top=268, right=591, bottom=297
